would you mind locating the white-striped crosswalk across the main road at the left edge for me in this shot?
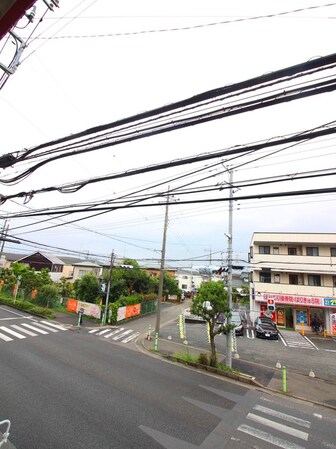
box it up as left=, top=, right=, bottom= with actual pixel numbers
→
left=0, top=320, right=67, bottom=343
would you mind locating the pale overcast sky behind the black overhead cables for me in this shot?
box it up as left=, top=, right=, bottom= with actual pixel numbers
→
left=0, top=0, right=336, bottom=268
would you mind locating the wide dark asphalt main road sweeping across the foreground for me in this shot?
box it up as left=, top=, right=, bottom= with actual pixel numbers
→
left=0, top=307, right=336, bottom=449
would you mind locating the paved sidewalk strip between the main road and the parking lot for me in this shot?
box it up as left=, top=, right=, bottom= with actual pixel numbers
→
left=142, top=337, right=336, bottom=410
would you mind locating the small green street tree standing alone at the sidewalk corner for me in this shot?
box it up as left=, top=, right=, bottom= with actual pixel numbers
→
left=191, top=281, right=231, bottom=366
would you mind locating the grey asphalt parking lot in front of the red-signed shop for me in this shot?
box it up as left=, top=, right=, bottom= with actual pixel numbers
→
left=160, top=320, right=336, bottom=382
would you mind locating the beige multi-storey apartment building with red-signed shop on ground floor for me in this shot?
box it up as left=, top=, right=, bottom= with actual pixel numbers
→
left=249, top=232, right=336, bottom=335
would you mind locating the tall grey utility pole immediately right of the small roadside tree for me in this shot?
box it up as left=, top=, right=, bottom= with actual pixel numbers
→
left=226, top=170, right=233, bottom=368
